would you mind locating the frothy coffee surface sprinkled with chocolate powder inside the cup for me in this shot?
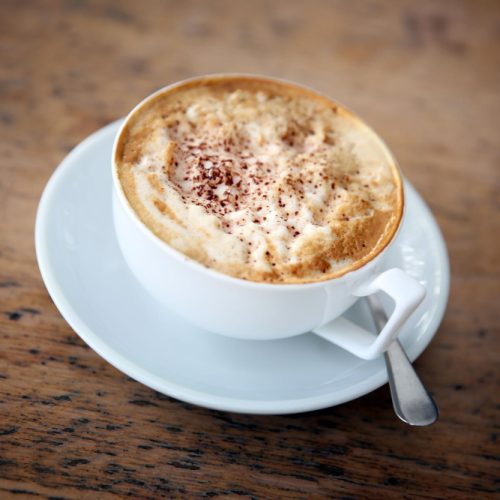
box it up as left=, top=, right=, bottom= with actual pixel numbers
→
left=115, top=75, right=403, bottom=283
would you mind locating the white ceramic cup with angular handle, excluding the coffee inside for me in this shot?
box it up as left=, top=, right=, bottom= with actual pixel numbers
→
left=112, top=76, right=425, bottom=359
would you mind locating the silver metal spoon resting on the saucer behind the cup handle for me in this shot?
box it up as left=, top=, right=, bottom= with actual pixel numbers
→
left=367, top=295, right=439, bottom=426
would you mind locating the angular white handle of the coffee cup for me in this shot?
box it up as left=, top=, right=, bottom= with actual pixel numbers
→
left=313, top=268, right=425, bottom=359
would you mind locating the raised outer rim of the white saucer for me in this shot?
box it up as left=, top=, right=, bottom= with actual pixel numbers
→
left=35, top=119, right=450, bottom=415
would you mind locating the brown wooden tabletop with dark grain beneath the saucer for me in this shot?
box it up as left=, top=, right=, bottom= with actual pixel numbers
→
left=0, top=0, right=500, bottom=498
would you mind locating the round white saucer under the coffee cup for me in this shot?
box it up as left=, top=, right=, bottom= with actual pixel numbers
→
left=36, top=122, right=449, bottom=414
